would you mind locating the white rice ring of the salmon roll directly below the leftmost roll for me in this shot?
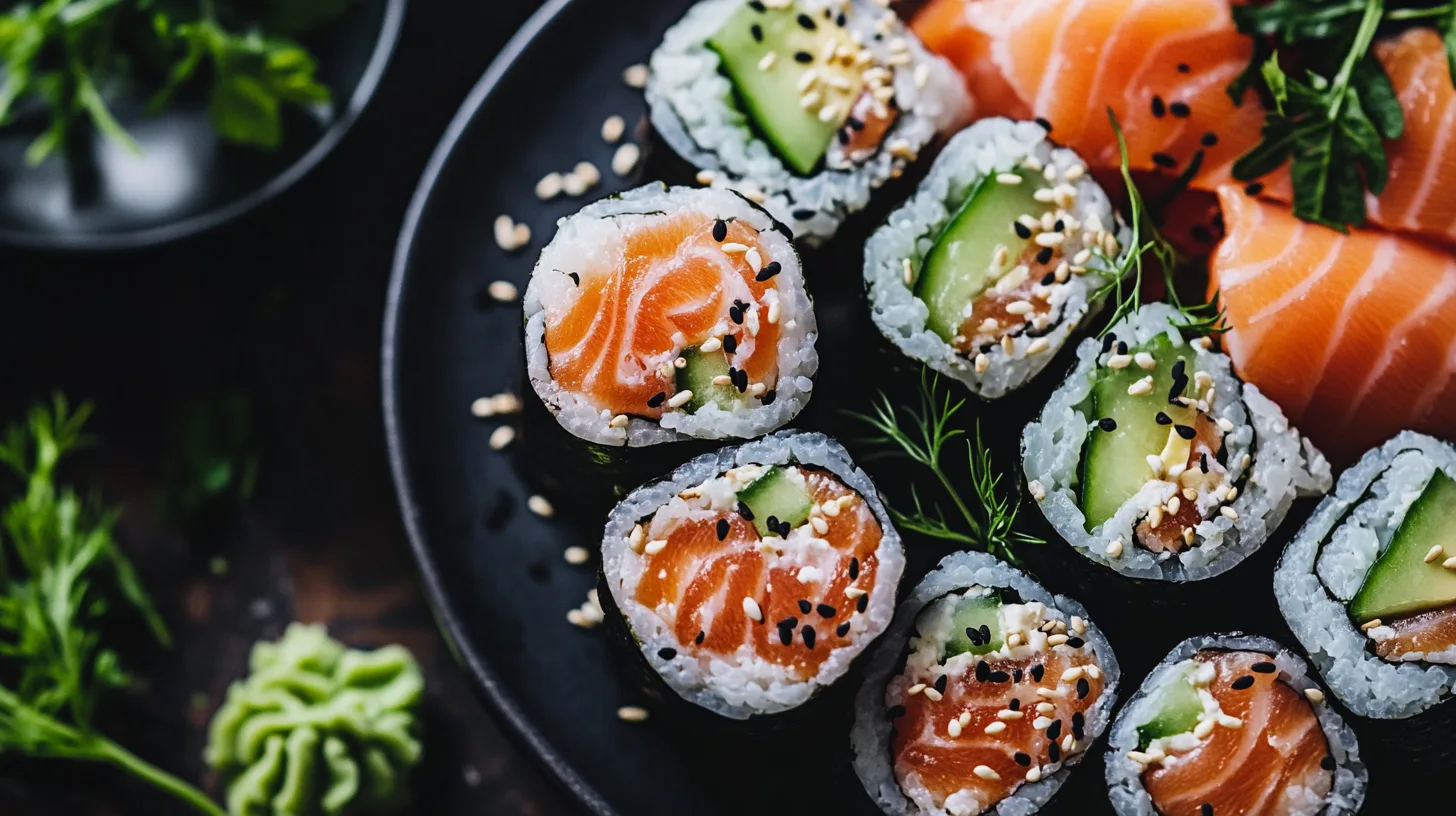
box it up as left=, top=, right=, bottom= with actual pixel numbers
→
left=601, top=431, right=904, bottom=720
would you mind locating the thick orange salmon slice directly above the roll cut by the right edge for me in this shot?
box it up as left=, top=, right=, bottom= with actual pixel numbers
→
left=1208, top=187, right=1456, bottom=462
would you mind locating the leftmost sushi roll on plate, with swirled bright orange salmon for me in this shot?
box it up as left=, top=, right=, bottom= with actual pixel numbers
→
left=524, top=185, right=818, bottom=445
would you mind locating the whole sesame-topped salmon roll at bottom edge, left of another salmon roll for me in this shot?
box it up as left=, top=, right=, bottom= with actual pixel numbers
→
left=850, top=552, right=1118, bottom=816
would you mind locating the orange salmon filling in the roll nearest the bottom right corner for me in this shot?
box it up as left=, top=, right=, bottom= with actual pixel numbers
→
left=1143, top=651, right=1334, bottom=816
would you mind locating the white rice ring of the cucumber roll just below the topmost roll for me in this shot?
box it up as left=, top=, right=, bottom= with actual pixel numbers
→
left=865, top=118, right=1131, bottom=399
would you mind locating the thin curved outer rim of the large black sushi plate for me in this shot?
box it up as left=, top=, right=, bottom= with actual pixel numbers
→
left=380, top=0, right=616, bottom=816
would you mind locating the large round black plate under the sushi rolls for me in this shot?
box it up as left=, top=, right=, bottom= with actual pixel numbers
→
left=383, top=0, right=1409, bottom=816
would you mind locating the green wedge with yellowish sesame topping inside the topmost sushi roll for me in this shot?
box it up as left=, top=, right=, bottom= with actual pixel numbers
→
left=708, top=3, right=863, bottom=176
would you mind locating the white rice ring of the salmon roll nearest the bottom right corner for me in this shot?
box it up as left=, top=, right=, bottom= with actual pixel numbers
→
left=1105, top=632, right=1369, bottom=816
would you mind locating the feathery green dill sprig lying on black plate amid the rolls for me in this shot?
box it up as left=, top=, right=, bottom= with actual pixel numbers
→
left=852, top=369, right=1044, bottom=564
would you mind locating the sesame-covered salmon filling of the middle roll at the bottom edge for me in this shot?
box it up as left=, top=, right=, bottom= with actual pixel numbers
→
left=885, top=587, right=1104, bottom=813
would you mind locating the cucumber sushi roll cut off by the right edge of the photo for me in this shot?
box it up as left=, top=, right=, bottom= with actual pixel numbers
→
left=1274, top=433, right=1456, bottom=718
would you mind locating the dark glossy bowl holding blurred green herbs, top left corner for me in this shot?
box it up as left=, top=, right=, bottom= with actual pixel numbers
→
left=0, top=0, right=405, bottom=251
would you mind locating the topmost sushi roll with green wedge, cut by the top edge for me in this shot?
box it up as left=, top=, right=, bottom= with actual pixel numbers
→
left=646, top=0, right=970, bottom=242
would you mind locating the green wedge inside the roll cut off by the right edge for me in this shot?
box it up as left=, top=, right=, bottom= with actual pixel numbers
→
left=1350, top=469, right=1456, bottom=624
